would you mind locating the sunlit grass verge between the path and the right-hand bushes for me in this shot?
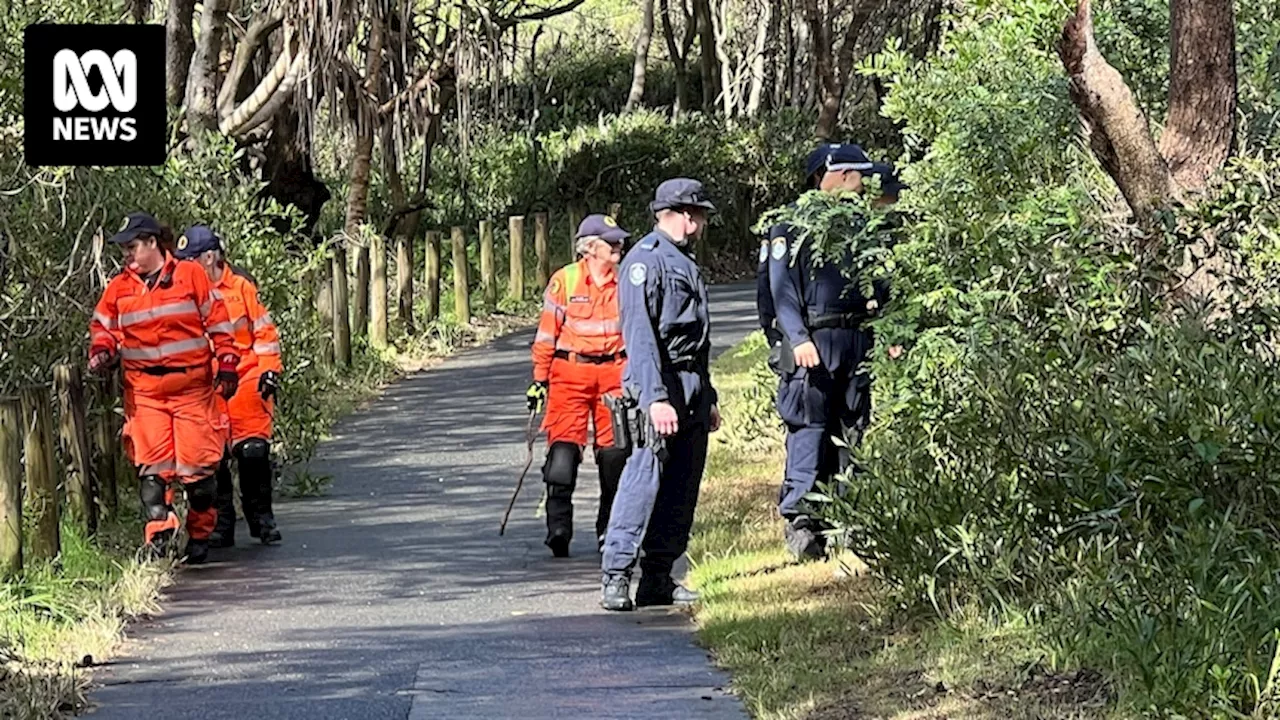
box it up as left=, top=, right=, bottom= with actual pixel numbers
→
left=690, top=333, right=1112, bottom=720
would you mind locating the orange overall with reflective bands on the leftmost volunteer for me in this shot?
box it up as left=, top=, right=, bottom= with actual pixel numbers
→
left=90, top=256, right=238, bottom=543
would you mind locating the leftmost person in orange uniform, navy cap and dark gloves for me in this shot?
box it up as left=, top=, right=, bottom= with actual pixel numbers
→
left=88, top=213, right=239, bottom=564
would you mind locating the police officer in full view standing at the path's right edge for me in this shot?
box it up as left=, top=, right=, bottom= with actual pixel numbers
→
left=600, top=178, right=719, bottom=610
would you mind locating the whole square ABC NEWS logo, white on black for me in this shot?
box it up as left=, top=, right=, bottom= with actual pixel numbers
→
left=23, top=24, right=166, bottom=165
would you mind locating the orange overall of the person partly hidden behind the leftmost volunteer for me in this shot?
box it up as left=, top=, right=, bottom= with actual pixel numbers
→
left=218, top=265, right=284, bottom=447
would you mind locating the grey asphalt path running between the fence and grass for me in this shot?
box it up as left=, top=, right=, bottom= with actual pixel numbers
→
left=90, top=286, right=755, bottom=720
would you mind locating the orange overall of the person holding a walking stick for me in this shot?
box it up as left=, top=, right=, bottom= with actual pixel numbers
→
left=532, top=260, right=626, bottom=447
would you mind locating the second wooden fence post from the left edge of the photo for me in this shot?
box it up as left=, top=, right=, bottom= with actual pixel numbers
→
left=22, top=387, right=60, bottom=560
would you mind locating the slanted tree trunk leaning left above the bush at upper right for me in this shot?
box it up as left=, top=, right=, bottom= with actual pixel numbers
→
left=1057, top=0, right=1175, bottom=223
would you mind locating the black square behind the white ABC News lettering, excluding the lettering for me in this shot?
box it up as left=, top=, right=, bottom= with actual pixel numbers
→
left=23, top=24, right=166, bottom=167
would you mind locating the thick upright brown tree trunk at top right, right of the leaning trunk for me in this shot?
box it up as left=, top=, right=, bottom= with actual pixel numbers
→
left=1160, top=0, right=1236, bottom=190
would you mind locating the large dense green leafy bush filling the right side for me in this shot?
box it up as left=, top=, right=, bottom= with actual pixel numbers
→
left=798, top=1, right=1280, bottom=717
